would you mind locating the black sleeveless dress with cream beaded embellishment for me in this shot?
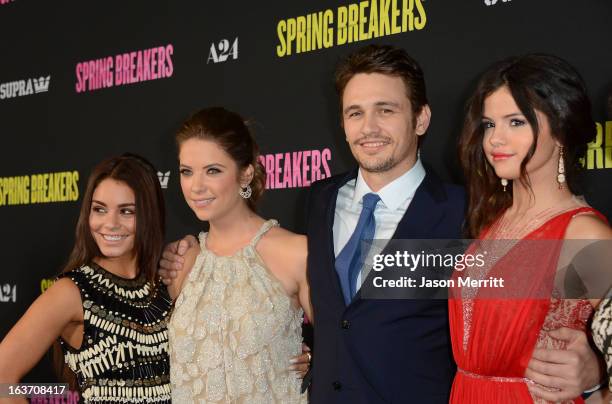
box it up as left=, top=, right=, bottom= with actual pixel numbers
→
left=58, top=262, right=172, bottom=403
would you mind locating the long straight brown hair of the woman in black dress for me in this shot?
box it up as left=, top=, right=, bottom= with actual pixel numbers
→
left=53, top=153, right=166, bottom=390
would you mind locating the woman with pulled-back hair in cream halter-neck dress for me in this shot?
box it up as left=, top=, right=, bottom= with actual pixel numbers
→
left=169, top=108, right=310, bottom=404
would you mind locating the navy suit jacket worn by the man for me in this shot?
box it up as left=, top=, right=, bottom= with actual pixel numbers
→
left=307, top=170, right=465, bottom=404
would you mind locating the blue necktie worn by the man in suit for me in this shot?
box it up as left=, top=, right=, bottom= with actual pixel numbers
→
left=336, top=193, right=380, bottom=306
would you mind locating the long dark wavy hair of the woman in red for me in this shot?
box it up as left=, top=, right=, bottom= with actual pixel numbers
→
left=459, top=54, right=596, bottom=237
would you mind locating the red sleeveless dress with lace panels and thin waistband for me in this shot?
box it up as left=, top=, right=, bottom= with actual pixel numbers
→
left=449, top=207, right=603, bottom=404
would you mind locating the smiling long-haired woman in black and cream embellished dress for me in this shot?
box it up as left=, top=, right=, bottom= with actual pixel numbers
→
left=0, top=154, right=172, bottom=403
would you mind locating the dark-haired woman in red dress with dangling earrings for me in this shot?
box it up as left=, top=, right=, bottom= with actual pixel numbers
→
left=449, top=54, right=612, bottom=404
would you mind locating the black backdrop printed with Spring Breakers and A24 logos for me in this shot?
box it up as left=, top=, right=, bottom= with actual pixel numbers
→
left=0, top=0, right=612, bottom=382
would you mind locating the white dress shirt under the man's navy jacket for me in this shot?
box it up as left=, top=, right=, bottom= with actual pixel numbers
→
left=333, top=158, right=425, bottom=289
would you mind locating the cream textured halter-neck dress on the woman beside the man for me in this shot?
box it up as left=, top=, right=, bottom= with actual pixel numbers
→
left=168, top=220, right=306, bottom=404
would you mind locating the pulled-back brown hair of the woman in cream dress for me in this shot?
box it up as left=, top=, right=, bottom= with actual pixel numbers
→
left=176, top=107, right=266, bottom=211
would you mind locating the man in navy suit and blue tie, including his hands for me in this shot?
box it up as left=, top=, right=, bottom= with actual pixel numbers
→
left=160, top=45, right=601, bottom=404
